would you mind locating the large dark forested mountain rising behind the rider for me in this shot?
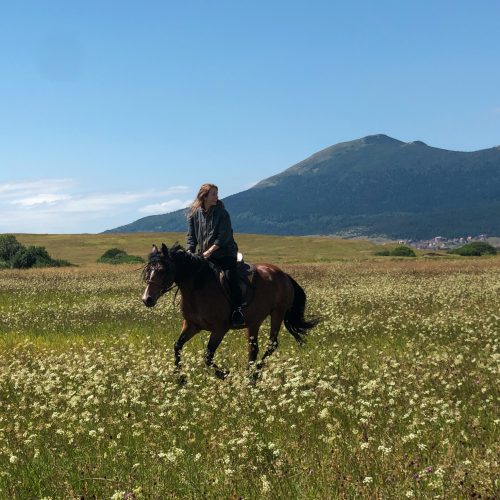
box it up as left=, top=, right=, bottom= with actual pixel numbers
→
left=106, top=134, right=500, bottom=239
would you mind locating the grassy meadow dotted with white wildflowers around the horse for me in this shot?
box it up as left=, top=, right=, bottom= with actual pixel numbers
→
left=0, top=234, right=500, bottom=500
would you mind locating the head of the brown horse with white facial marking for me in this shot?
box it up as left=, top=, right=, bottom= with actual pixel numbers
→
left=142, top=243, right=175, bottom=307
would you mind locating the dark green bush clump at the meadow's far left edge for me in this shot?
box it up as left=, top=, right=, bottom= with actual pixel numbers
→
left=0, top=234, right=71, bottom=269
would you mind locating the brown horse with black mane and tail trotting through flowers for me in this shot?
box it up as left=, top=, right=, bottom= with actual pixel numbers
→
left=142, top=244, right=318, bottom=378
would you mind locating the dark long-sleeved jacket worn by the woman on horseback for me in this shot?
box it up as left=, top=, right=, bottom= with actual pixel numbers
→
left=187, top=201, right=238, bottom=259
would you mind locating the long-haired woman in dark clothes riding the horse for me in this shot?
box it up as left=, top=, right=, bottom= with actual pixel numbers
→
left=187, top=184, right=245, bottom=326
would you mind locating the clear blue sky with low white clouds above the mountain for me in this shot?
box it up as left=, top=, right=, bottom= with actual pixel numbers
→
left=0, top=0, right=500, bottom=233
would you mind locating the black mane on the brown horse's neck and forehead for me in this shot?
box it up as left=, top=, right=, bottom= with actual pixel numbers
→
left=142, top=242, right=215, bottom=288
